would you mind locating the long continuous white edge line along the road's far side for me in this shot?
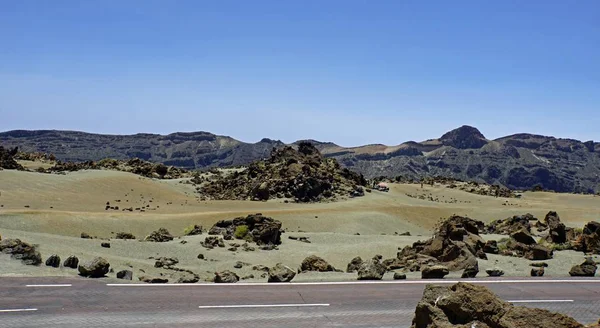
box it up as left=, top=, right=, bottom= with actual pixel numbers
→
left=106, top=279, right=600, bottom=287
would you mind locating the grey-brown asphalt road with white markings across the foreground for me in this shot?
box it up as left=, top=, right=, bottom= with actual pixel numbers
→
left=0, top=278, right=600, bottom=328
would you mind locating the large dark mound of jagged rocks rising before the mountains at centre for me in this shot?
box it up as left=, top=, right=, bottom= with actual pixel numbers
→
left=199, top=142, right=366, bottom=203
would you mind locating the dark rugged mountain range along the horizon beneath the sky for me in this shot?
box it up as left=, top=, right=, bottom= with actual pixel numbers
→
left=0, top=126, right=600, bottom=192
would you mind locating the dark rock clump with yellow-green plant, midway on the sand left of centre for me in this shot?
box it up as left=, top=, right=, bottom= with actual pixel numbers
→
left=208, top=213, right=282, bottom=245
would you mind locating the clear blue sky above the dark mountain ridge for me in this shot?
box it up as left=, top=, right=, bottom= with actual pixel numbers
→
left=0, top=0, right=600, bottom=146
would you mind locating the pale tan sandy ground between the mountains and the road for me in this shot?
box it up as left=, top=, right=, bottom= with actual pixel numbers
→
left=0, top=170, right=600, bottom=281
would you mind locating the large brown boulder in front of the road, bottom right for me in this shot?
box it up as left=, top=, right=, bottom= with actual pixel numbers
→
left=411, top=282, right=584, bottom=328
